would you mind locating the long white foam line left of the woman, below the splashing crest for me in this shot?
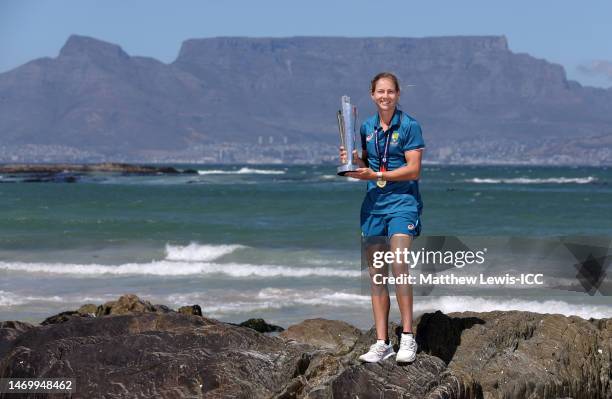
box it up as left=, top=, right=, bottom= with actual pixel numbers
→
left=0, top=260, right=360, bottom=278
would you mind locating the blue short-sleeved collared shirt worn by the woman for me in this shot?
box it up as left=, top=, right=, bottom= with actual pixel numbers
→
left=360, top=108, right=425, bottom=214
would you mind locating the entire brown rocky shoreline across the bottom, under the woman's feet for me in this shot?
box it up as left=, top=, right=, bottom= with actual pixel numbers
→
left=0, top=295, right=612, bottom=399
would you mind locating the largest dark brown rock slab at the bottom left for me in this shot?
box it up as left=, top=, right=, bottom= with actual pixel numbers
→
left=0, top=313, right=314, bottom=398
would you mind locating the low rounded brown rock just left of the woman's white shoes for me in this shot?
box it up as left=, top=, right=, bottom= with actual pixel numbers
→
left=280, top=319, right=361, bottom=355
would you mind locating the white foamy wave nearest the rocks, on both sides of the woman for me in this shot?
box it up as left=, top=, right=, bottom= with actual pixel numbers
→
left=0, top=287, right=612, bottom=319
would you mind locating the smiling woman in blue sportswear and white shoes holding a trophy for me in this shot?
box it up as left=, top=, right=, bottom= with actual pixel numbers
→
left=340, top=72, right=425, bottom=362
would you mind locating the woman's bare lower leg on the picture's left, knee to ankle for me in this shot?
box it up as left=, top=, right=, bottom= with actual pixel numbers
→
left=367, top=244, right=391, bottom=340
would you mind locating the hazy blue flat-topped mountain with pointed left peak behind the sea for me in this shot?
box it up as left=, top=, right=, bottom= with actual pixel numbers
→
left=0, top=35, right=612, bottom=164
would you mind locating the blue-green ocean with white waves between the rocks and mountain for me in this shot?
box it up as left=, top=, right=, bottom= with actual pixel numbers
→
left=0, top=165, right=612, bottom=329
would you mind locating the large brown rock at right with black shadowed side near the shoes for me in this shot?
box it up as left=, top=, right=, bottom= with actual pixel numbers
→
left=417, top=311, right=612, bottom=399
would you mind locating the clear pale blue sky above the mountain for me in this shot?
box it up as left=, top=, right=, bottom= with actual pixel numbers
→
left=0, top=0, right=612, bottom=87
